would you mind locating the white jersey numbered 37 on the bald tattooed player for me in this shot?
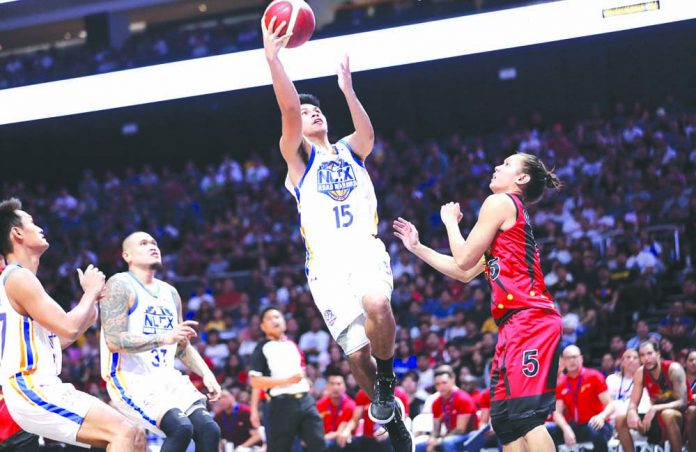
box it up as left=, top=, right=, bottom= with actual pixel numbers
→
left=100, top=272, right=178, bottom=380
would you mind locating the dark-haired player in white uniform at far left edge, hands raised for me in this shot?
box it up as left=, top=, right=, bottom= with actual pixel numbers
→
left=0, top=198, right=145, bottom=451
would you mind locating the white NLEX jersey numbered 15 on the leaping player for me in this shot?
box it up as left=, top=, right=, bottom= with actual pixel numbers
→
left=285, top=140, right=378, bottom=275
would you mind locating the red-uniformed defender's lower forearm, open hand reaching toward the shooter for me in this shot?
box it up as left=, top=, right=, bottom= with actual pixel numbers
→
left=393, top=217, right=485, bottom=283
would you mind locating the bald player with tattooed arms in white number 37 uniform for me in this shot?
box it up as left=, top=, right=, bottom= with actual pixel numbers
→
left=99, top=232, right=221, bottom=452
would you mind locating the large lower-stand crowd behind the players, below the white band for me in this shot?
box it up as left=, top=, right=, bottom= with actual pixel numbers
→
left=2, top=98, right=696, bottom=448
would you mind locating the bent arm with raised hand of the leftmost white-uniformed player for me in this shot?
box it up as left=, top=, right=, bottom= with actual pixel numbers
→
left=5, top=265, right=105, bottom=346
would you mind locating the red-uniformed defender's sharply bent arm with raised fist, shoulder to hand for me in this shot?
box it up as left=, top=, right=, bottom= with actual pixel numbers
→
left=440, top=194, right=515, bottom=270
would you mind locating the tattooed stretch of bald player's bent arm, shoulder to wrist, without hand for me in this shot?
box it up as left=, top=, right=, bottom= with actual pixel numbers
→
left=99, top=277, right=162, bottom=353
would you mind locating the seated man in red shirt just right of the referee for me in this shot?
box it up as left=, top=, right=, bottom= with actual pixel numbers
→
left=317, top=373, right=355, bottom=447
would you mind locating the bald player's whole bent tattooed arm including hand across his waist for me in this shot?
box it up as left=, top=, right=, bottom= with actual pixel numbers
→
left=99, top=276, right=197, bottom=353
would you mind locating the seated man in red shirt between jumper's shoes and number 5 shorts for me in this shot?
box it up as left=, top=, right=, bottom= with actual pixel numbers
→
left=416, top=365, right=478, bottom=452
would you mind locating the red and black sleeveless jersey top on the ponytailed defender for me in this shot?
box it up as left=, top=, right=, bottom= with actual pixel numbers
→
left=485, top=193, right=556, bottom=324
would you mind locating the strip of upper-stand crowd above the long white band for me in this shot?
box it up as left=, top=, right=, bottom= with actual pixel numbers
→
left=0, top=0, right=525, bottom=89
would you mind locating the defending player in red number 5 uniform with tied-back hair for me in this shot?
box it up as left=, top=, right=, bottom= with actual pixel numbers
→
left=394, top=153, right=561, bottom=452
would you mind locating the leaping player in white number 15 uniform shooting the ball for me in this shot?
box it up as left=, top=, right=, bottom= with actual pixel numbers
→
left=261, top=18, right=412, bottom=451
